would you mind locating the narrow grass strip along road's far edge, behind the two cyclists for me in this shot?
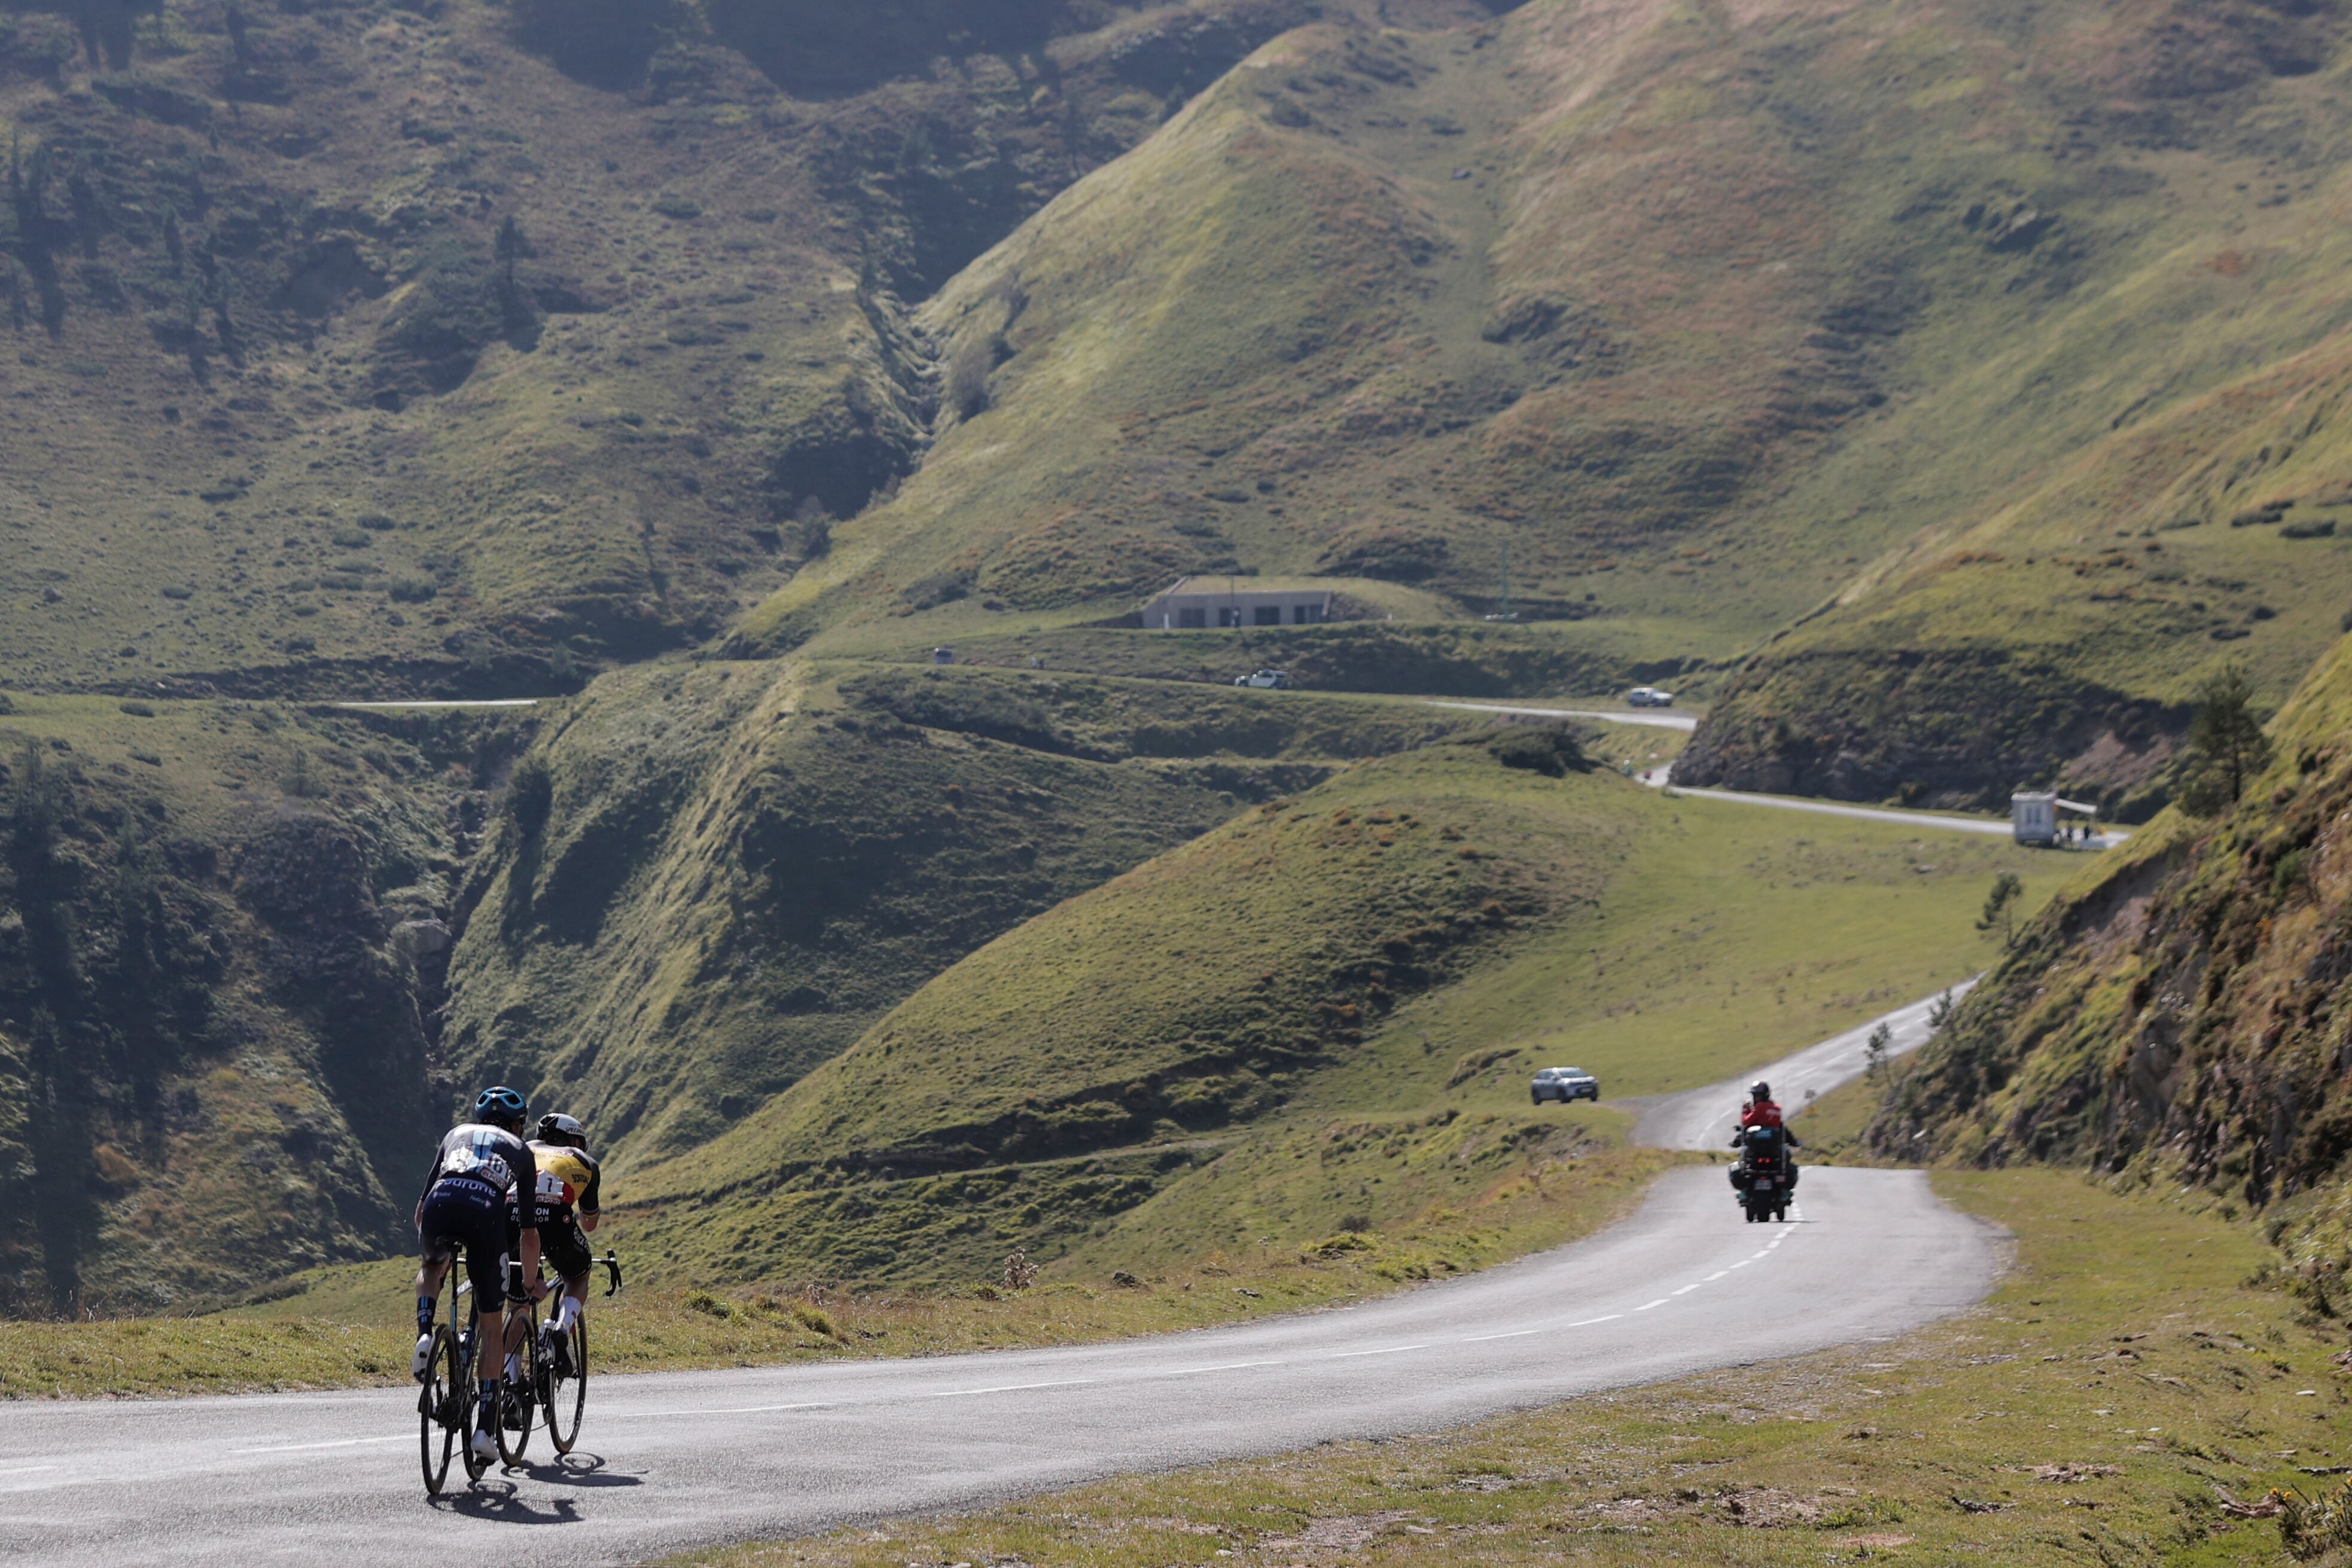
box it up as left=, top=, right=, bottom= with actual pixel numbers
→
left=0, top=1133, right=1679, bottom=1399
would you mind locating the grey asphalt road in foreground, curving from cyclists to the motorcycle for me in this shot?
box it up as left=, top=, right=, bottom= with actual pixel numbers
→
left=0, top=1169, right=1994, bottom=1568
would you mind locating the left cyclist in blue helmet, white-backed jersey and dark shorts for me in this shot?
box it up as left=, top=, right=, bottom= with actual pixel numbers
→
left=412, top=1086, right=546, bottom=1457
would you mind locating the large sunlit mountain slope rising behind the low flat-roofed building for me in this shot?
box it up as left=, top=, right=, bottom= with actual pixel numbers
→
left=739, top=0, right=2345, bottom=691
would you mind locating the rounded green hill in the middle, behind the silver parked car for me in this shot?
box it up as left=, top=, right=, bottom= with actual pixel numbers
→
left=630, top=733, right=2054, bottom=1279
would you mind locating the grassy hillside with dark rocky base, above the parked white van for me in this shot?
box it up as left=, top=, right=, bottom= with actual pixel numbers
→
left=1681, top=336, right=2352, bottom=820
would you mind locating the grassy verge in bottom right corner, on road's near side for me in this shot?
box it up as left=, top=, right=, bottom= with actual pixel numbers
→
left=671, top=1171, right=2352, bottom=1568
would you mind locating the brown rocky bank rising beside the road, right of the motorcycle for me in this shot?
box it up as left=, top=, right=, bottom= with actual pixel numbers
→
left=1870, top=630, right=2352, bottom=1209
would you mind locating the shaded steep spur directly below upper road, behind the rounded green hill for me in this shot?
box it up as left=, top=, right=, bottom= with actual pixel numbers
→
left=444, top=665, right=1477, bottom=1169
